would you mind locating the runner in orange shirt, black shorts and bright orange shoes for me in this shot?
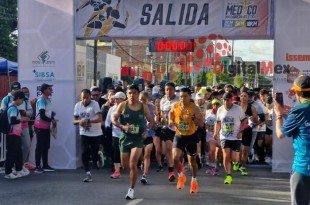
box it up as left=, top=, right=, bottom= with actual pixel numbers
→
left=169, top=88, right=203, bottom=193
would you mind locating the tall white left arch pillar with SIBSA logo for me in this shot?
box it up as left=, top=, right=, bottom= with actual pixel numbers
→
left=18, top=0, right=79, bottom=169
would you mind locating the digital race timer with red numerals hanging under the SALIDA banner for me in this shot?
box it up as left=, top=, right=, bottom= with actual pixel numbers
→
left=149, top=38, right=195, bottom=52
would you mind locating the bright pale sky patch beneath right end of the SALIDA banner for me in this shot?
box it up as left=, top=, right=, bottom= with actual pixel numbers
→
left=234, top=40, right=274, bottom=61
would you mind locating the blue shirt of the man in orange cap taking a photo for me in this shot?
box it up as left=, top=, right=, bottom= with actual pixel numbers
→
left=281, top=103, right=310, bottom=176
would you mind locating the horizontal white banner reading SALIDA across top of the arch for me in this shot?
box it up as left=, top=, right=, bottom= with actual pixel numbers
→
left=76, top=0, right=273, bottom=39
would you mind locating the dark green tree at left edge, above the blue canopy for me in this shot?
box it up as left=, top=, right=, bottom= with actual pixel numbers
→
left=0, top=0, right=17, bottom=61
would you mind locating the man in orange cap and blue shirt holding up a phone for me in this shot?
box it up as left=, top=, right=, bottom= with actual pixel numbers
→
left=274, top=75, right=310, bottom=205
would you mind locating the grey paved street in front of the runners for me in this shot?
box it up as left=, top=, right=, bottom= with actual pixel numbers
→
left=0, top=166, right=290, bottom=205
